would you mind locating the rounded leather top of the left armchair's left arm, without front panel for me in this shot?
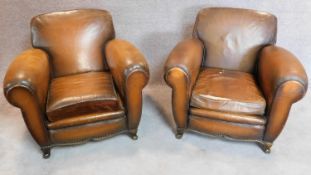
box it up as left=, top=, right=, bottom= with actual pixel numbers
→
left=3, top=49, right=51, bottom=110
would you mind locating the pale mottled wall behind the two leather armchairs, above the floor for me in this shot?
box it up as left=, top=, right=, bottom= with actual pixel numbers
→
left=0, top=0, right=311, bottom=84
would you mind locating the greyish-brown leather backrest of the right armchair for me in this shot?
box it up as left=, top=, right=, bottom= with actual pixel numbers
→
left=193, top=8, right=277, bottom=72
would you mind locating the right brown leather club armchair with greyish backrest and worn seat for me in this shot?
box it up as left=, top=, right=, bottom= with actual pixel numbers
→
left=165, top=8, right=308, bottom=153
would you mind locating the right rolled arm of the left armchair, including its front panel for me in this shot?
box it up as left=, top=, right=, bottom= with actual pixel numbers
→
left=106, top=39, right=149, bottom=132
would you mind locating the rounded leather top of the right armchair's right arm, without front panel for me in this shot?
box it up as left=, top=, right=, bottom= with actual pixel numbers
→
left=258, top=46, right=308, bottom=105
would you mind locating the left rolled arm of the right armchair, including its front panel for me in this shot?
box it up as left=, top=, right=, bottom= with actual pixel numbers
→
left=164, top=39, right=204, bottom=132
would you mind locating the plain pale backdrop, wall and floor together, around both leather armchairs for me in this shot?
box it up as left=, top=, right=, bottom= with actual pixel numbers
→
left=0, top=0, right=311, bottom=175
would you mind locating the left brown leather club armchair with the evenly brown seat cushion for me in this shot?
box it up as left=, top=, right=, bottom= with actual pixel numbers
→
left=4, top=9, right=149, bottom=158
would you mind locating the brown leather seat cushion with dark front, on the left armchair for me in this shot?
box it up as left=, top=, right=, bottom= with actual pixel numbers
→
left=46, top=72, right=123, bottom=121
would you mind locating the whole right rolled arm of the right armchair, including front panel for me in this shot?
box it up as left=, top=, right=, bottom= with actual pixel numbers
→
left=258, top=46, right=308, bottom=142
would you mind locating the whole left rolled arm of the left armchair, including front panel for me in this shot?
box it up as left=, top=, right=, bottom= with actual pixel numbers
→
left=3, top=49, right=50, bottom=146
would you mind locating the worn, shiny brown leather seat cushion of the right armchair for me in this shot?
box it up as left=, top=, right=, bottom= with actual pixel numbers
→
left=191, top=68, right=266, bottom=115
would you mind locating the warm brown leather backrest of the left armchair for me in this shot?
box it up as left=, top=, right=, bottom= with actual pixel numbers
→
left=31, top=9, right=115, bottom=77
